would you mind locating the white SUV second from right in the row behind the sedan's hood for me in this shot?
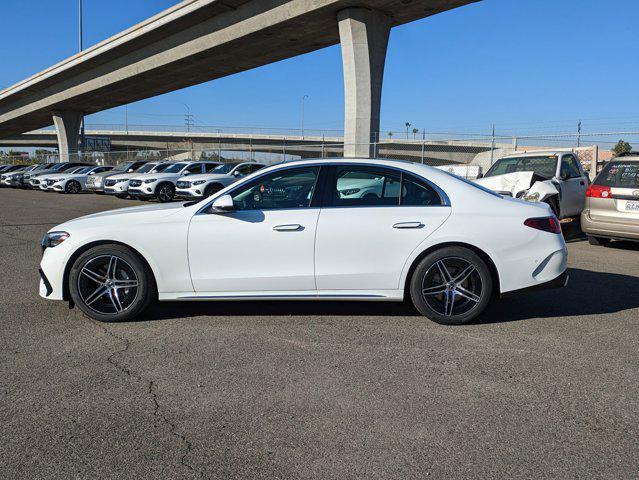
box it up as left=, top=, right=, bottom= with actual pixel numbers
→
left=128, top=162, right=219, bottom=203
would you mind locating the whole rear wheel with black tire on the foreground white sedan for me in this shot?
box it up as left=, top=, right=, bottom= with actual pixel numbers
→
left=410, top=247, right=493, bottom=325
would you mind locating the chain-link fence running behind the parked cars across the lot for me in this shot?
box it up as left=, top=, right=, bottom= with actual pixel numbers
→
left=0, top=128, right=639, bottom=181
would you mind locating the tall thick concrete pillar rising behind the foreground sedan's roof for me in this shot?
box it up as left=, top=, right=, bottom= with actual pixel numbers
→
left=337, top=7, right=391, bottom=158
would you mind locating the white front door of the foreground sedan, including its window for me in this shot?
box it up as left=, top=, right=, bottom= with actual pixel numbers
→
left=188, top=167, right=320, bottom=296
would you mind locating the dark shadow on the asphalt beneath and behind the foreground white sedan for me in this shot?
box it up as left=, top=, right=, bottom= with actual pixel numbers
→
left=131, top=269, right=639, bottom=324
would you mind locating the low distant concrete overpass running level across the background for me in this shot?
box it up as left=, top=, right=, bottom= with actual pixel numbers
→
left=0, top=129, right=502, bottom=165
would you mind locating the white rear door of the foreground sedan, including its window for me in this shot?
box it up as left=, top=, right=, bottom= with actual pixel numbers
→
left=315, top=164, right=450, bottom=294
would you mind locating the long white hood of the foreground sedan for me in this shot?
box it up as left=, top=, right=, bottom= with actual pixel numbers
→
left=52, top=203, right=184, bottom=231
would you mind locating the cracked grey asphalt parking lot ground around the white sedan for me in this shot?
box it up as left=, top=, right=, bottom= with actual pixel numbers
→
left=0, top=189, right=639, bottom=479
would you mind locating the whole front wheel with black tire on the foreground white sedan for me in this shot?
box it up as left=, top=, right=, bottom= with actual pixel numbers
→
left=69, top=244, right=156, bottom=322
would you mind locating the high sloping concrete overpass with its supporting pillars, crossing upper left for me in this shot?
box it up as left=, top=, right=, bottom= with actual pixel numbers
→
left=0, top=0, right=478, bottom=161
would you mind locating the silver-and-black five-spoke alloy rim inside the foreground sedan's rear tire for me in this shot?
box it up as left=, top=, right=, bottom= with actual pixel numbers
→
left=421, top=257, right=483, bottom=317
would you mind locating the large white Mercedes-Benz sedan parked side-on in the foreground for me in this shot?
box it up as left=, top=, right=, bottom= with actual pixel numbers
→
left=40, top=159, right=568, bottom=324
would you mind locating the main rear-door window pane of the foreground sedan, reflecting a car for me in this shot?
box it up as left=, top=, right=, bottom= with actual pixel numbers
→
left=330, top=165, right=401, bottom=207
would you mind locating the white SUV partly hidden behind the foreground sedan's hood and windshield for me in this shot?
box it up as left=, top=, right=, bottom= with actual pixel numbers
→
left=175, top=162, right=266, bottom=199
